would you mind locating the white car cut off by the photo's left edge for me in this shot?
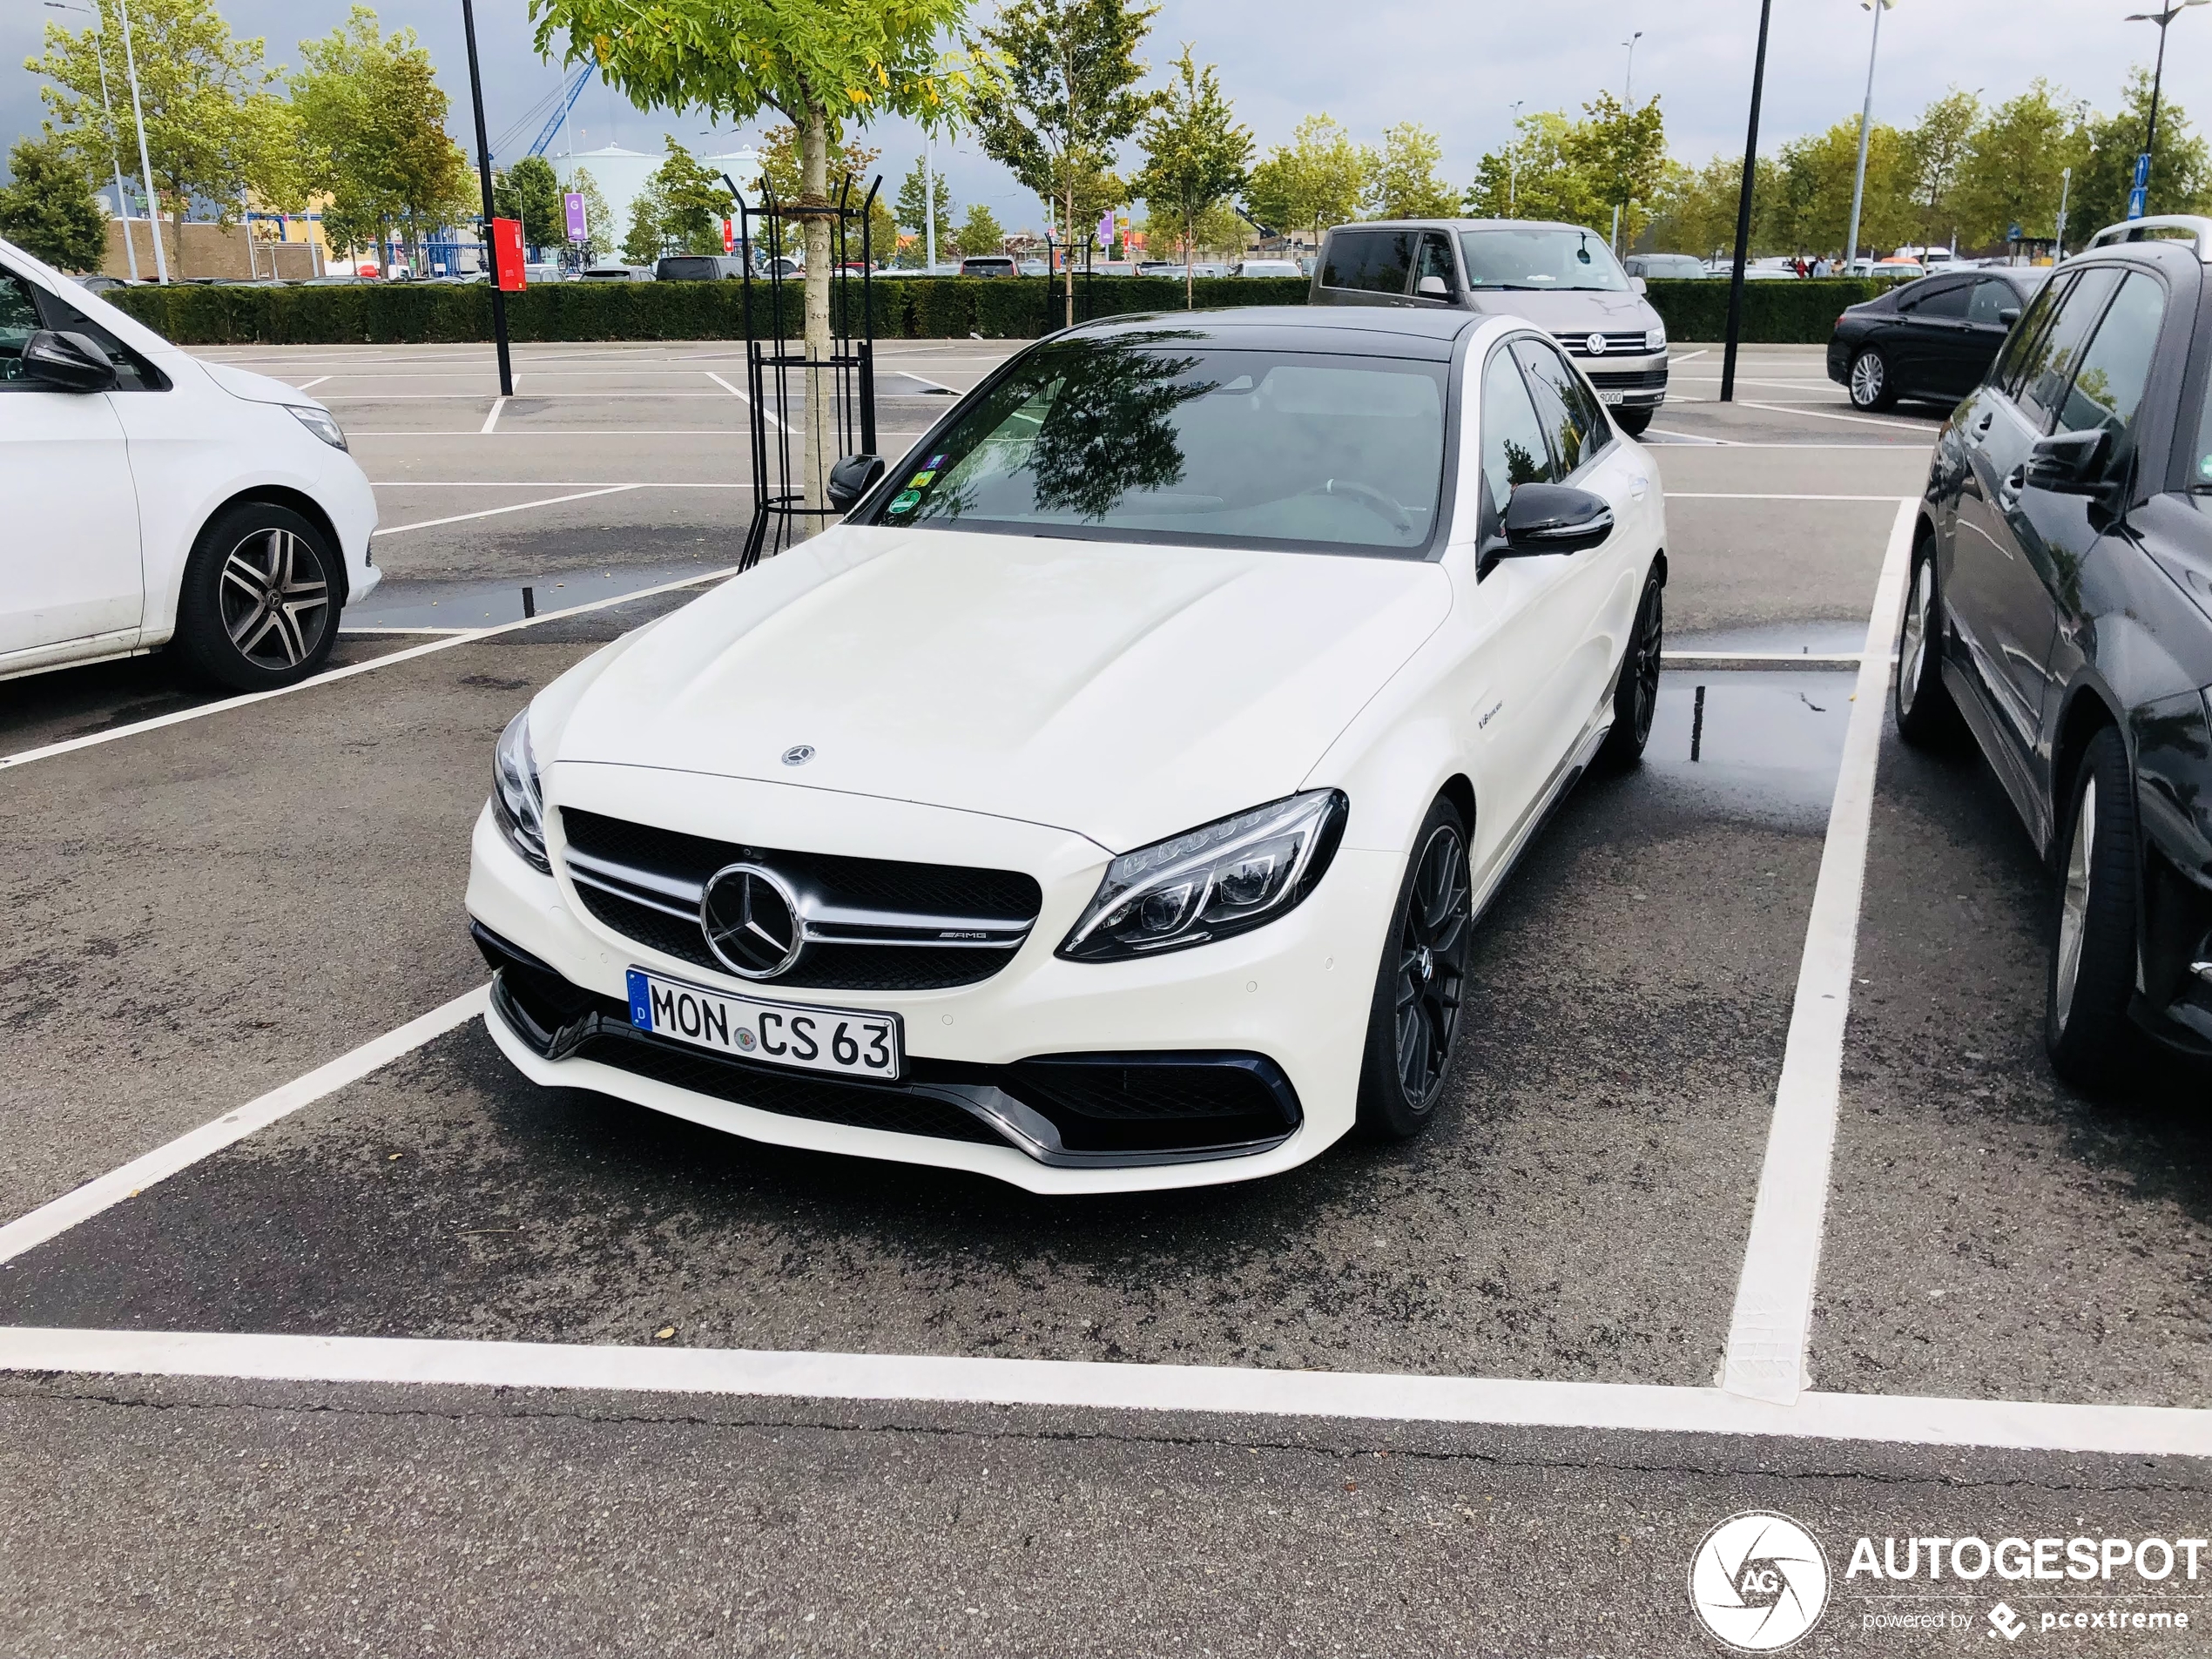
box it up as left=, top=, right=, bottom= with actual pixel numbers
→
left=0, top=241, right=378, bottom=690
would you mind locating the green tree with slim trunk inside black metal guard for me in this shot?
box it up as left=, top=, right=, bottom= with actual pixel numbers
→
left=531, top=0, right=987, bottom=511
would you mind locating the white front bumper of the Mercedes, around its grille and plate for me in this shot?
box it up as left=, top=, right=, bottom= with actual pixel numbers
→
left=469, top=772, right=1402, bottom=1192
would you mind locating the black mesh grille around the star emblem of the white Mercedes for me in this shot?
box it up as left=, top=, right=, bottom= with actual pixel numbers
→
left=562, top=807, right=1044, bottom=991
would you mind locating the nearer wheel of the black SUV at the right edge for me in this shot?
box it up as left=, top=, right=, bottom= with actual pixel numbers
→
left=2044, top=725, right=2137, bottom=1090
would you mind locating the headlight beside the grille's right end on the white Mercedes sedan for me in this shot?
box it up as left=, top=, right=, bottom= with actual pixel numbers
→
left=1060, top=790, right=1349, bottom=962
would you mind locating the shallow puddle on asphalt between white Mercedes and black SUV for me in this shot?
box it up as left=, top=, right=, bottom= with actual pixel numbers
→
left=1643, top=668, right=1858, bottom=830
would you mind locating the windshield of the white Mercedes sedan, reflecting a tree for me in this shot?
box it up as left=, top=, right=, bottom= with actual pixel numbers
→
left=876, top=329, right=1447, bottom=553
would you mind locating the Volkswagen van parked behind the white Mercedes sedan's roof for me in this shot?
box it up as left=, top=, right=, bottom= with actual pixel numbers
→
left=1307, top=219, right=1668, bottom=438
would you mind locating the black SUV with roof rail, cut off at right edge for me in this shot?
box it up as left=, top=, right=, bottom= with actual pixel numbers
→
left=1896, top=217, right=2212, bottom=1086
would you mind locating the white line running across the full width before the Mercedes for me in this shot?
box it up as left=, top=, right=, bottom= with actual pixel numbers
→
left=0, top=1325, right=2212, bottom=1458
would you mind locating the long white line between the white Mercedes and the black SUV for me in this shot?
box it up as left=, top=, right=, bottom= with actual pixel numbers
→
left=1721, top=496, right=1920, bottom=1405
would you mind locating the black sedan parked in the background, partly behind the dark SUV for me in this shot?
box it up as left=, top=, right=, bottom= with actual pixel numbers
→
left=1827, top=266, right=2051, bottom=409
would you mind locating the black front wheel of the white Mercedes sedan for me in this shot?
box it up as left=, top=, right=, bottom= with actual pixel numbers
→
left=1359, top=799, right=1474, bottom=1142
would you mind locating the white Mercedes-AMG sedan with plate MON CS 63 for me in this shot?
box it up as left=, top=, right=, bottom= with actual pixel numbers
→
left=469, top=307, right=1666, bottom=1192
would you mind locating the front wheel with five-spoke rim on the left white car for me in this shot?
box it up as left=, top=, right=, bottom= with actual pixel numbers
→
left=175, top=502, right=341, bottom=690
